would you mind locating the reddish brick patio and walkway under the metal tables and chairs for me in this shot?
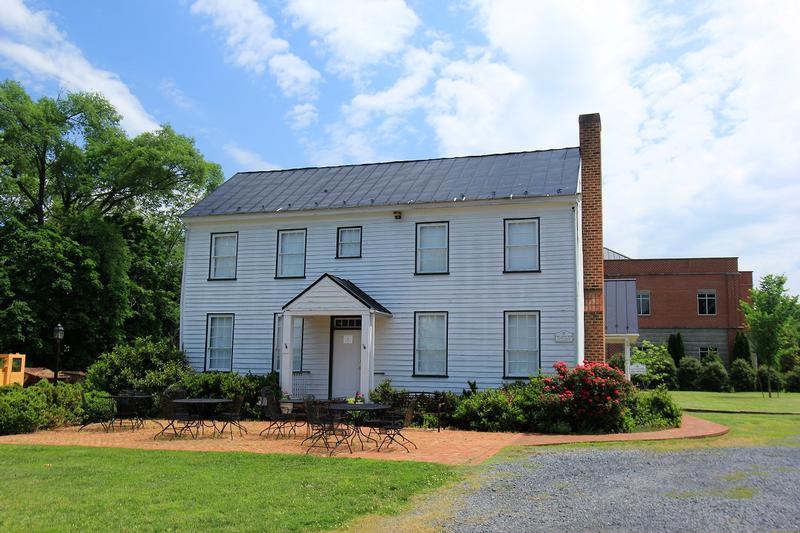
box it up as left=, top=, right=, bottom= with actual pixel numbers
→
left=0, top=415, right=728, bottom=465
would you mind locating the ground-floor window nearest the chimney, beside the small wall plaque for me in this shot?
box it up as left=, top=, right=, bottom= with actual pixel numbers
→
left=505, top=311, right=539, bottom=378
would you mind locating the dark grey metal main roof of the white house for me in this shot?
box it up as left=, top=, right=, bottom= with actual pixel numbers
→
left=184, top=147, right=580, bottom=217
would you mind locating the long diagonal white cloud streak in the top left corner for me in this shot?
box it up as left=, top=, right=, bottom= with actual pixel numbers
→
left=0, top=0, right=159, bottom=134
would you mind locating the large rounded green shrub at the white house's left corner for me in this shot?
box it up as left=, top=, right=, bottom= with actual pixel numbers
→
left=86, top=337, right=192, bottom=394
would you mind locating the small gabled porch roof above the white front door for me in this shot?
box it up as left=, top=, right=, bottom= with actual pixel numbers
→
left=283, top=273, right=392, bottom=316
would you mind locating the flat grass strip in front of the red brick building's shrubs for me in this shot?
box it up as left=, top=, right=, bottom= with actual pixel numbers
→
left=670, top=391, right=800, bottom=415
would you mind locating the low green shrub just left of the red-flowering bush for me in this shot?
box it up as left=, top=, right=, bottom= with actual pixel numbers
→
left=453, top=389, right=524, bottom=431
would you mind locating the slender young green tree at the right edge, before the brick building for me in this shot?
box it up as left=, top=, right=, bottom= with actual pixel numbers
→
left=741, top=274, right=800, bottom=397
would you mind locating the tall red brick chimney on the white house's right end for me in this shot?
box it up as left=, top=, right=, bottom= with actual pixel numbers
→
left=578, top=113, right=606, bottom=362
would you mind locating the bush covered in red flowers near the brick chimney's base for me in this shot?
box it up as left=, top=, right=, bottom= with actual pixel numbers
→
left=543, top=361, right=633, bottom=431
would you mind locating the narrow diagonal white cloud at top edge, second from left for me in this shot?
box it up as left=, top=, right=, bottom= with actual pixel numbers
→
left=191, top=0, right=321, bottom=97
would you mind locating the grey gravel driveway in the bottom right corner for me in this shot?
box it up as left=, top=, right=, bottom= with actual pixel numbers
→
left=439, top=448, right=800, bottom=532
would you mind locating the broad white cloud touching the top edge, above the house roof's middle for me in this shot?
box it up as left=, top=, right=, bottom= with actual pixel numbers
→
left=286, top=0, right=420, bottom=74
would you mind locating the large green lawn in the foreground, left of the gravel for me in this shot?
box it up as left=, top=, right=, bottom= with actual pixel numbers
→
left=0, top=445, right=461, bottom=531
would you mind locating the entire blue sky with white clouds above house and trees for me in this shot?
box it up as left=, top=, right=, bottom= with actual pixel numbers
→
left=0, top=0, right=800, bottom=294
